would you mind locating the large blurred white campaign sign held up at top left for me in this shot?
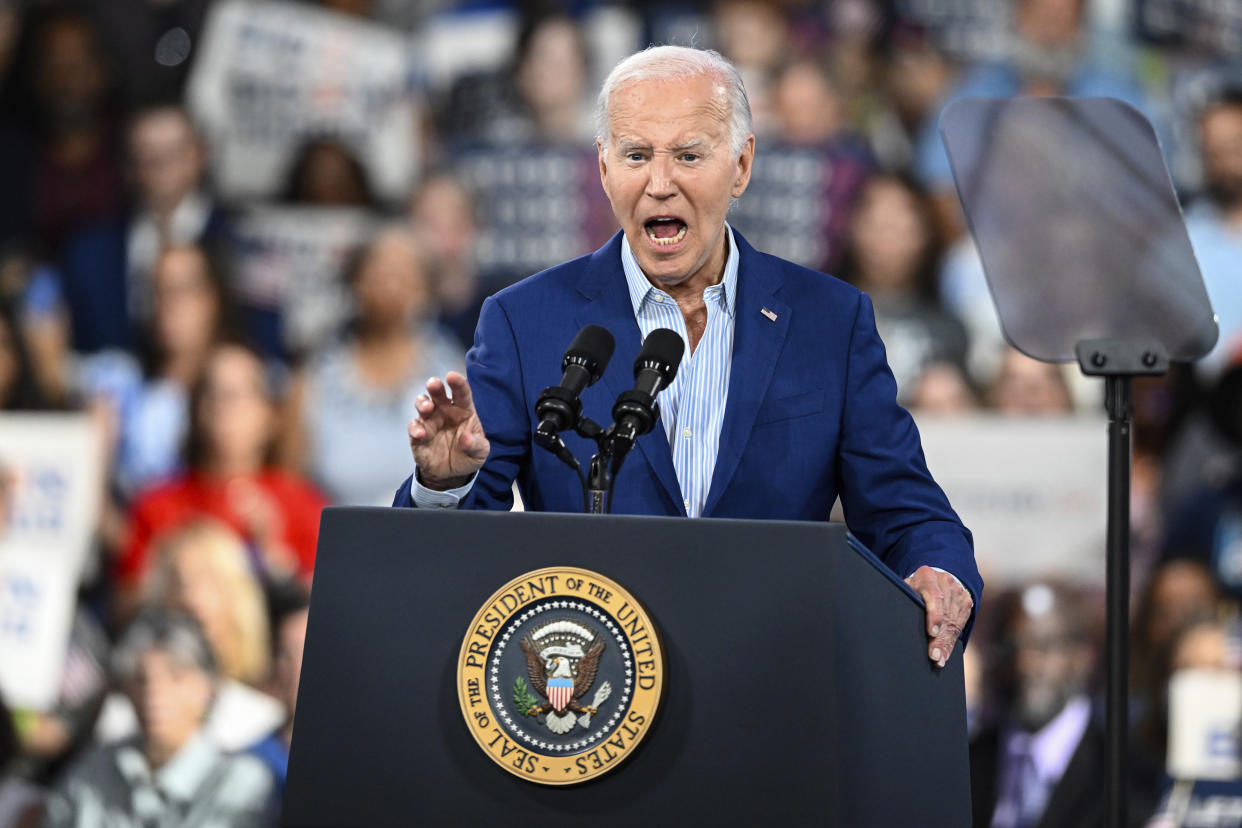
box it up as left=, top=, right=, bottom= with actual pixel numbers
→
left=188, top=0, right=416, bottom=201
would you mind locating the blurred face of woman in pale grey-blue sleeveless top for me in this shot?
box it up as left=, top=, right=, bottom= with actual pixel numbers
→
left=353, top=231, right=431, bottom=330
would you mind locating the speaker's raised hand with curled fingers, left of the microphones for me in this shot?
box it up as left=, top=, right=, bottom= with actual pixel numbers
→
left=406, top=371, right=492, bottom=492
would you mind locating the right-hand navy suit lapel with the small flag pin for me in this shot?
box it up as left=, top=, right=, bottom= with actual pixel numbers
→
left=703, top=232, right=792, bottom=515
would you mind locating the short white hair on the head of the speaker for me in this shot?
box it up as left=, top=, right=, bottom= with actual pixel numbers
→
left=595, top=46, right=751, bottom=155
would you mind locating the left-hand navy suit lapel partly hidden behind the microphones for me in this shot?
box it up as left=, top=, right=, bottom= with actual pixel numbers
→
left=574, top=232, right=686, bottom=514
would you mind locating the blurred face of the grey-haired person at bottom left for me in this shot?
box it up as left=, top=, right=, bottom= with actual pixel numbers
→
left=124, top=648, right=212, bottom=758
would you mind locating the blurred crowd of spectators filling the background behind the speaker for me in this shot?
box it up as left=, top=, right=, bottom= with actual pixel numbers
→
left=0, top=0, right=1242, bottom=827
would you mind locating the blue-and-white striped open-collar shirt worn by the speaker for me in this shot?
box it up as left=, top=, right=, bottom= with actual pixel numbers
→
left=410, top=225, right=738, bottom=518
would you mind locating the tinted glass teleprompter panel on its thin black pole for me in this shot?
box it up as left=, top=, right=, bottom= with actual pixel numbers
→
left=940, top=98, right=1217, bottom=828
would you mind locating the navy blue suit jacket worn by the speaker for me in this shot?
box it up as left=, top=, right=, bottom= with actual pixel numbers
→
left=394, top=232, right=982, bottom=618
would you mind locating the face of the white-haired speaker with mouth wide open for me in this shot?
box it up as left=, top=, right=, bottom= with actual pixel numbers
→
left=599, top=76, right=755, bottom=290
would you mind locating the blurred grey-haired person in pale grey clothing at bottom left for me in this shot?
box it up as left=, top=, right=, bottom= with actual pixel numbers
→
left=47, top=611, right=273, bottom=828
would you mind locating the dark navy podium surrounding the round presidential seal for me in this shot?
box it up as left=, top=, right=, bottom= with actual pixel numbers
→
left=283, top=509, right=970, bottom=828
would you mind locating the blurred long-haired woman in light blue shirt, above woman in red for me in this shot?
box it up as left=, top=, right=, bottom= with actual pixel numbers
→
left=81, top=245, right=235, bottom=497
